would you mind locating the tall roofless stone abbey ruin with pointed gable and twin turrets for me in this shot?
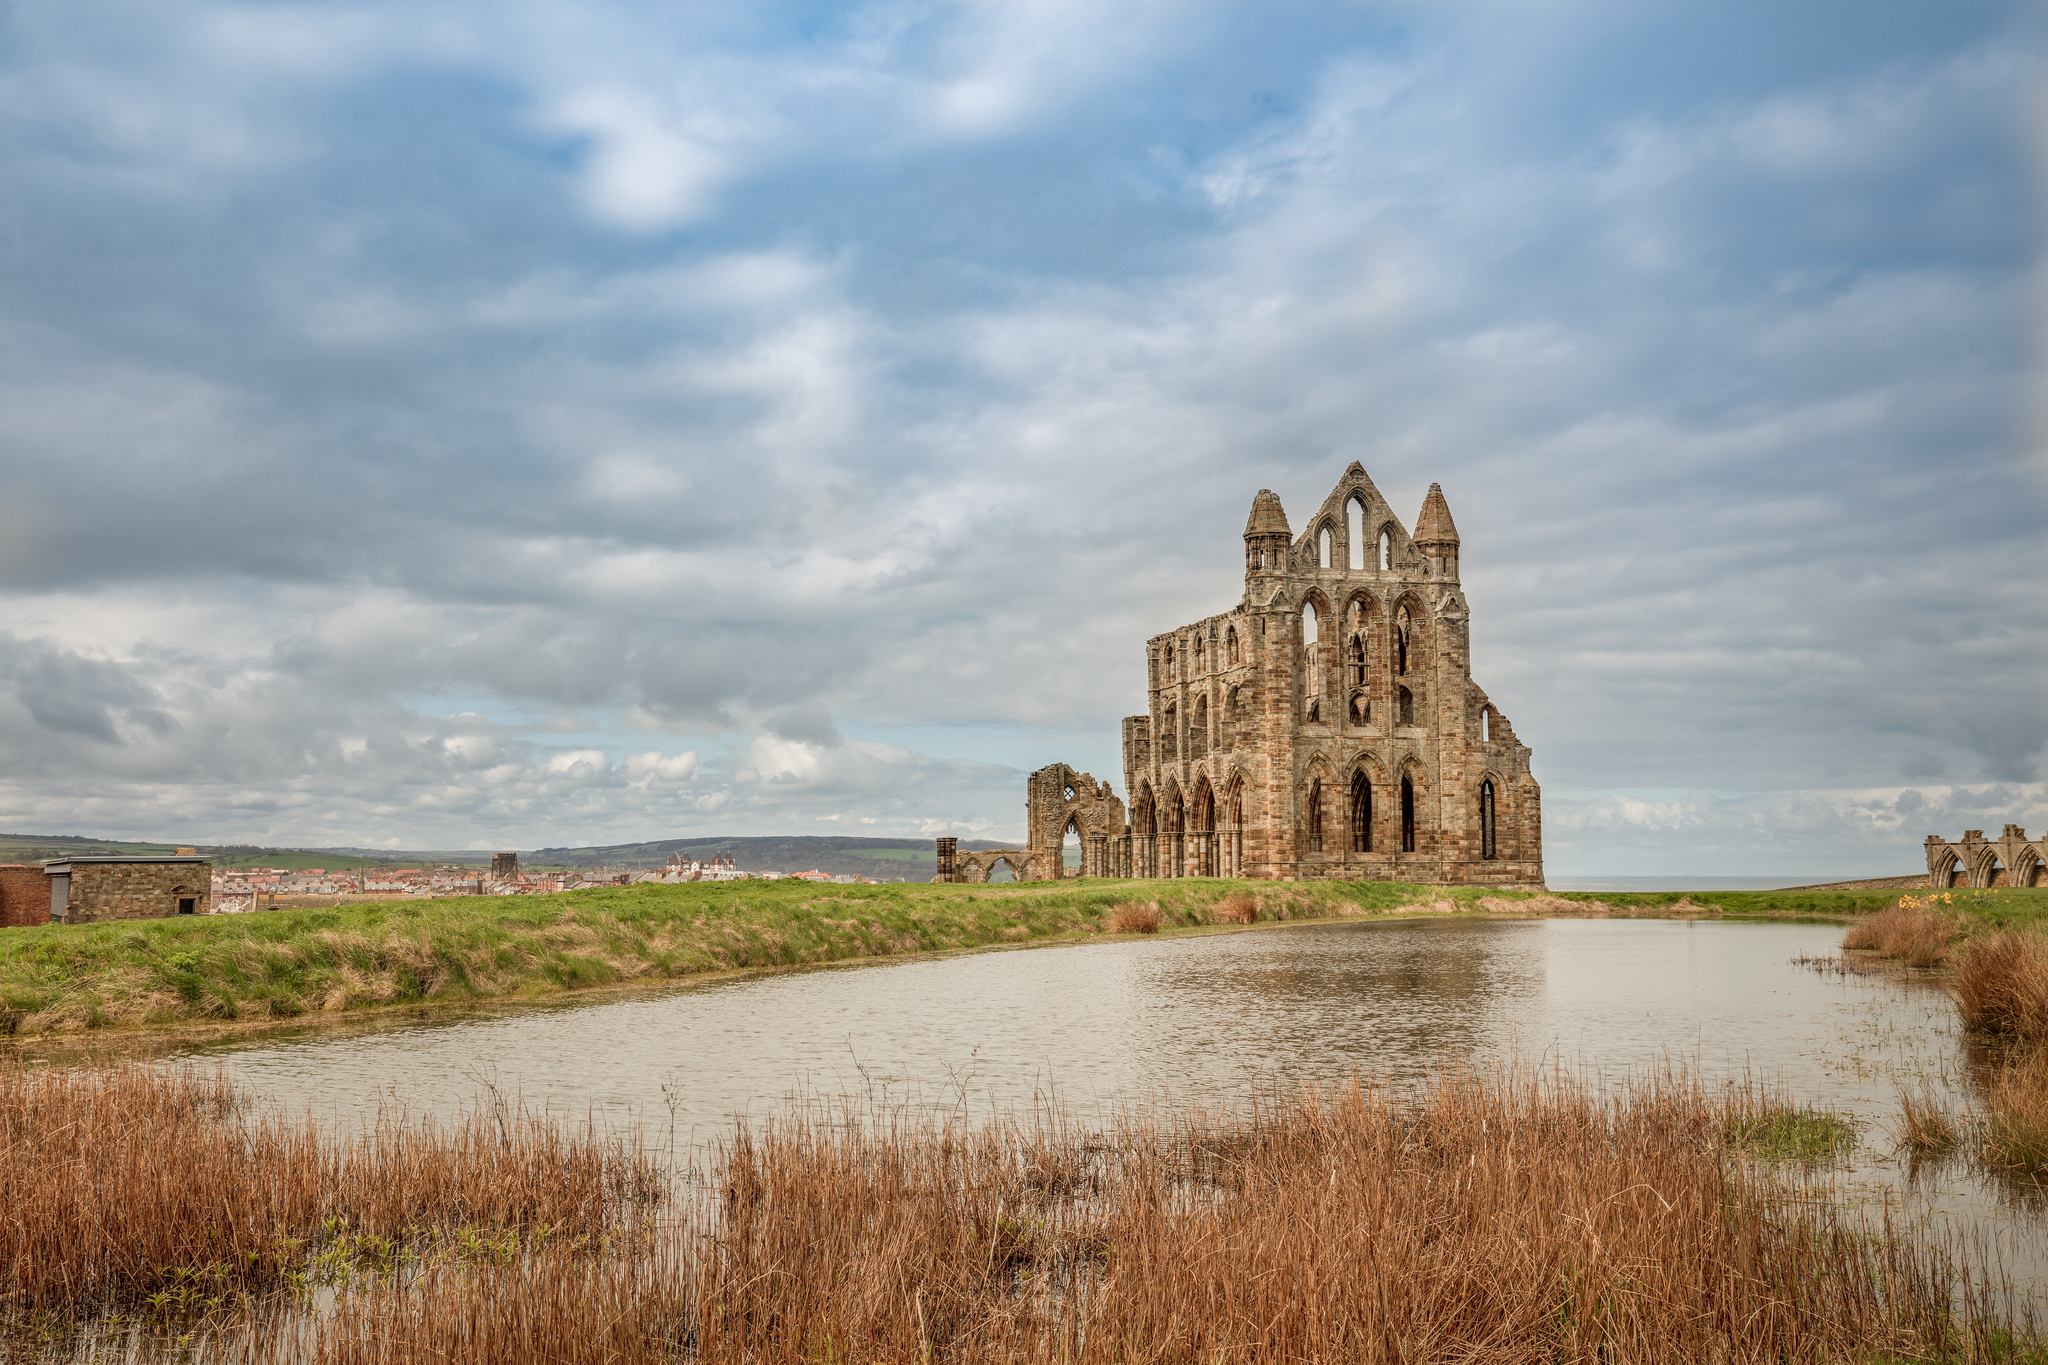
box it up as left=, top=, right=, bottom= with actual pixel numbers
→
left=1122, top=465, right=1542, bottom=888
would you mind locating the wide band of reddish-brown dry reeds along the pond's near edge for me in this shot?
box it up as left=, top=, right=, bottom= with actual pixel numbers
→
left=0, top=1066, right=2038, bottom=1365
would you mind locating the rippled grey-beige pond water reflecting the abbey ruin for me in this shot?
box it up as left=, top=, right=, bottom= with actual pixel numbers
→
left=172, top=919, right=1933, bottom=1136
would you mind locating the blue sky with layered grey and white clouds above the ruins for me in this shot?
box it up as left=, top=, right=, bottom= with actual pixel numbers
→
left=0, top=0, right=2048, bottom=876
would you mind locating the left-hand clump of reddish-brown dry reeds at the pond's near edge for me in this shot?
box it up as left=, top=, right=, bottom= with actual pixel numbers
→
left=0, top=1064, right=662, bottom=1316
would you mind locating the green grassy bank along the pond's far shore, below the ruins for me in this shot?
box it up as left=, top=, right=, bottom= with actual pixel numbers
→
left=0, top=878, right=2048, bottom=1036
